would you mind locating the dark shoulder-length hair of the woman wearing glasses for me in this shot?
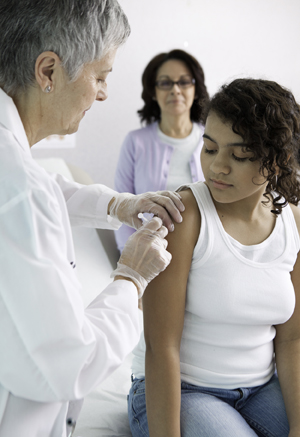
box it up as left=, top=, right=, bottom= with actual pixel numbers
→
left=137, top=49, right=209, bottom=125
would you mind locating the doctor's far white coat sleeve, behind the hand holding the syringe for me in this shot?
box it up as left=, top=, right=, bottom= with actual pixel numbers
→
left=51, top=174, right=121, bottom=229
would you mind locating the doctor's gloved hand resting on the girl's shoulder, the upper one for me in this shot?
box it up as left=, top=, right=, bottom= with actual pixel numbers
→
left=108, top=191, right=184, bottom=232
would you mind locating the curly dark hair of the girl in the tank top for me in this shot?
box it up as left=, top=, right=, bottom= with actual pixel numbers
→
left=202, top=79, right=300, bottom=215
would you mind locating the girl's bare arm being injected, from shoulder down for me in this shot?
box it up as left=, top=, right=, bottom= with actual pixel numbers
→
left=143, top=190, right=201, bottom=437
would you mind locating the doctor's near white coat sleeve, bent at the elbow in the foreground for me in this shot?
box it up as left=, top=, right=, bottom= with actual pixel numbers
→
left=0, top=184, right=139, bottom=402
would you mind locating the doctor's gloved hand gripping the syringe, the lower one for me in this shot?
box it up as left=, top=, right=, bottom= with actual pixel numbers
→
left=111, top=217, right=172, bottom=299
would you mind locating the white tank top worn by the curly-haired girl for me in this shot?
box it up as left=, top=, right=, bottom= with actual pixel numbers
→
left=132, top=182, right=300, bottom=389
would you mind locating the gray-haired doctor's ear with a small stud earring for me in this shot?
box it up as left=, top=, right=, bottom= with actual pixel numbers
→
left=35, top=52, right=61, bottom=93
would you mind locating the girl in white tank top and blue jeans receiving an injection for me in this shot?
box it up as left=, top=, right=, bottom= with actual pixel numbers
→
left=128, top=79, right=300, bottom=437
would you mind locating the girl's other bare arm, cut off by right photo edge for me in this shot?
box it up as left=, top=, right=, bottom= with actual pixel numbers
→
left=274, top=205, right=300, bottom=437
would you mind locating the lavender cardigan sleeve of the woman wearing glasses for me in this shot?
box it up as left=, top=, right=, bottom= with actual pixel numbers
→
left=115, top=133, right=137, bottom=252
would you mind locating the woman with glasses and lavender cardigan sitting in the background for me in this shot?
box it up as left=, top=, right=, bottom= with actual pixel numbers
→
left=115, top=50, right=208, bottom=251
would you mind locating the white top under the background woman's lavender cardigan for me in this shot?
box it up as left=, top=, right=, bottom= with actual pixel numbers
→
left=157, top=123, right=201, bottom=191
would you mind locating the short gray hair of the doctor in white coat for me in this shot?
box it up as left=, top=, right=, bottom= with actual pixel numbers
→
left=0, top=0, right=130, bottom=96
